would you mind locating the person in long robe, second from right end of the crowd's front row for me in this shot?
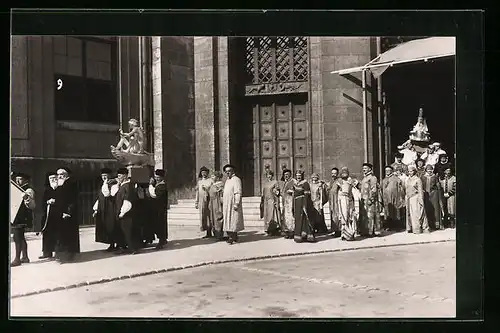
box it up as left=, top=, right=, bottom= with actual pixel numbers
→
left=420, top=164, right=444, bottom=230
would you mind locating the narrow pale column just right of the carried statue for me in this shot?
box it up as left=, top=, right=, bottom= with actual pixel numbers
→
left=151, top=37, right=165, bottom=169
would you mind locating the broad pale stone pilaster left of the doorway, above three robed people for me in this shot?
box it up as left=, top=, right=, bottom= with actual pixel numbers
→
left=194, top=37, right=216, bottom=170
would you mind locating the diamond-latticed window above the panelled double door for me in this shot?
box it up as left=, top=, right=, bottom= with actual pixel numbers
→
left=246, top=37, right=309, bottom=84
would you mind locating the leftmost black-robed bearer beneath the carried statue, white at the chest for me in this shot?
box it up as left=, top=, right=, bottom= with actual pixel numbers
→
left=93, top=168, right=118, bottom=252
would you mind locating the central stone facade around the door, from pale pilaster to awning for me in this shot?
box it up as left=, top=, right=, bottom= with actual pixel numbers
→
left=194, top=37, right=378, bottom=196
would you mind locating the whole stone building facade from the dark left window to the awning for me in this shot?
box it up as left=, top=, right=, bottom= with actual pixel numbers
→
left=11, top=36, right=426, bottom=219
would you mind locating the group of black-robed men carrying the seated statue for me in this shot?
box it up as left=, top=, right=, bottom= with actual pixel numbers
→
left=93, top=168, right=168, bottom=254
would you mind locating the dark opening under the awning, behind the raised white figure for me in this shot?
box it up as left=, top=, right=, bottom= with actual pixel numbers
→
left=382, top=58, right=455, bottom=160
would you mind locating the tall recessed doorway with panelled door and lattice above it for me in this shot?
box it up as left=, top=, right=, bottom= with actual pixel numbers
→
left=230, top=37, right=312, bottom=196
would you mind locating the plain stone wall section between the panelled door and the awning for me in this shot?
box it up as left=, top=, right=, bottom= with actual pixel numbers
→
left=310, top=37, right=373, bottom=179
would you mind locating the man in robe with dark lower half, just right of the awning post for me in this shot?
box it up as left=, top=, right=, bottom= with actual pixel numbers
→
left=382, top=165, right=405, bottom=229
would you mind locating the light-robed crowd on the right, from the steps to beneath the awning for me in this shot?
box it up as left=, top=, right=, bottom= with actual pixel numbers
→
left=195, top=141, right=456, bottom=244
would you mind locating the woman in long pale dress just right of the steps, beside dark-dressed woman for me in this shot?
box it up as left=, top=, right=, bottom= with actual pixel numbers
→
left=260, top=170, right=281, bottom=236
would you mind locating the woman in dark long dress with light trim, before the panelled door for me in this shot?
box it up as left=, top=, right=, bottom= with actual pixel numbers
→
left=293, top=171, right=316, bottom=243
